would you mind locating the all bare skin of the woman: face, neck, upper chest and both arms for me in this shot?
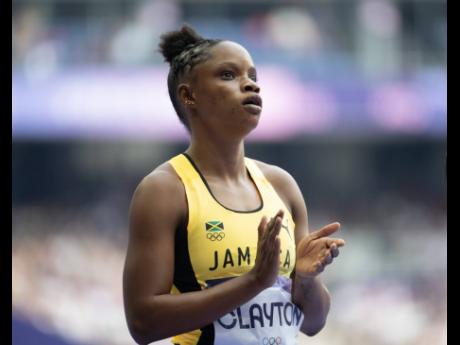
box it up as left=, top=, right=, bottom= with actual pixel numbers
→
left=123, top=41, right=344, bottom=344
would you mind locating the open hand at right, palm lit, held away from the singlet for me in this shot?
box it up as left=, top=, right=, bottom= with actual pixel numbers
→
left=295, top=222, right=345, bottom=278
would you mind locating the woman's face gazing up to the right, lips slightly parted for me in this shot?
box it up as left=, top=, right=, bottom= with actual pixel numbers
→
left=184, top=41, right=262, bottom=136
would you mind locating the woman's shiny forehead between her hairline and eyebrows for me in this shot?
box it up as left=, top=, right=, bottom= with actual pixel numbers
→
left=203, top=41, right=254, bottom=67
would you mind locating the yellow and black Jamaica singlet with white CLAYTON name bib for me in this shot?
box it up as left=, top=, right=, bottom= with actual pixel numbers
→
left=169, top=153, right=304, bottom=345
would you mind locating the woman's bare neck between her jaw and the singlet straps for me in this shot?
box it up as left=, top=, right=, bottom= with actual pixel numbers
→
left=185, top=135, right=247, bottom=181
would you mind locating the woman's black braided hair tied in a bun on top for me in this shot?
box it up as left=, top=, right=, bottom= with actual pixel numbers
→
left=159, top=25, right=222, bottom=132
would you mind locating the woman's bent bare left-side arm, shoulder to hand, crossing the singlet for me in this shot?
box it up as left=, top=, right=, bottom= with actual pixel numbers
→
left=123, top=167, right=281, bottom=344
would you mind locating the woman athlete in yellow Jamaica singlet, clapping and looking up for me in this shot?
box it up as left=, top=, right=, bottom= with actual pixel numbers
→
left=123, top=25, right=345, bottom=345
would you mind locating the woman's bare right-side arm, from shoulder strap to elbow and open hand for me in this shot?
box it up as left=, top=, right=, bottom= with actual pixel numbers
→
left=256, top=165, right=344, bottom=336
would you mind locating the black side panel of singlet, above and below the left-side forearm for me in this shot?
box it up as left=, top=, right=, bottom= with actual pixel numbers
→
left=173, top=210, right=215, bottom=345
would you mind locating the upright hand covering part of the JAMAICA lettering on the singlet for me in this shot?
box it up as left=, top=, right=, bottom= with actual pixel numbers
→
left=249, top=210, right=284, bottom=288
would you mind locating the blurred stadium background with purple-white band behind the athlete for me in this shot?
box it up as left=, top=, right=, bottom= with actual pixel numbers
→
left=12, top=0, right=447, bottom=345
